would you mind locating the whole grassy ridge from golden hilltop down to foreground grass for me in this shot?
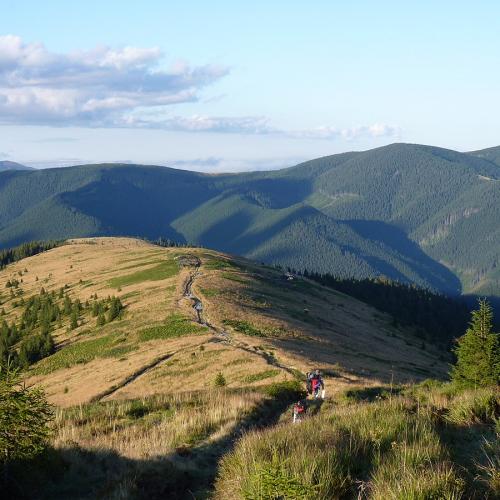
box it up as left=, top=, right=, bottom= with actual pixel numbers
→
left=0, top=238, right=498, bottom=500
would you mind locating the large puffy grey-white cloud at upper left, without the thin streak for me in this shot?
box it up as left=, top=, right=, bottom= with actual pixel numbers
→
left=0, top=35, right=228, bottom=126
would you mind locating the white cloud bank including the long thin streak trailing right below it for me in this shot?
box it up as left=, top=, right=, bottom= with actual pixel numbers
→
left=0, top=35, right=399, bottom=140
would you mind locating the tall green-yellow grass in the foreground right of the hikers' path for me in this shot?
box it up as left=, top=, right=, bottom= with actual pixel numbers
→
left=216, top=389, right=500, bottom=500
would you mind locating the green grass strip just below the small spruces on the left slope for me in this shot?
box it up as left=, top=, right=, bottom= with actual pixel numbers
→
left=33, top=334, right=136, bottom=375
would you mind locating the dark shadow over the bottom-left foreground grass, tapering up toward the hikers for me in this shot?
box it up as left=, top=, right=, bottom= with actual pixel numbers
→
left=4, top=390, right=303, bottom=500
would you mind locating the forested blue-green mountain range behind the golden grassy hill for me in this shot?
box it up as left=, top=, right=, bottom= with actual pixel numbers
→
left=0, top=144, right=500, bottom=295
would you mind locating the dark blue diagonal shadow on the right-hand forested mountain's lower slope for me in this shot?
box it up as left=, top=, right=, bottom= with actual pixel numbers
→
left=344, top=220, right=462, bottom=295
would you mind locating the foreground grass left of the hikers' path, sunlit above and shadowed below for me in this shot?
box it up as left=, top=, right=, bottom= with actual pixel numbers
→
left=3, top=389, right=269, bottom=500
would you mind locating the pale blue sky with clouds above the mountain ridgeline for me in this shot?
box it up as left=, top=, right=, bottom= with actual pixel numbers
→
left=0, top=0, right=500, bottom=172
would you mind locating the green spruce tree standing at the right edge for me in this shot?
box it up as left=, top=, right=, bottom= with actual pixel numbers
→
left=451, top=299, right=500, bottom=387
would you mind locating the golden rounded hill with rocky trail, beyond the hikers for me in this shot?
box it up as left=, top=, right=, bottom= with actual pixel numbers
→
left=0, top=238, right=447, bottom=406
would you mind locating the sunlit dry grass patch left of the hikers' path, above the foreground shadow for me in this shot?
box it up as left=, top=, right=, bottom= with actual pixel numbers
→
left=54, top=390, right=263, bottom=459
